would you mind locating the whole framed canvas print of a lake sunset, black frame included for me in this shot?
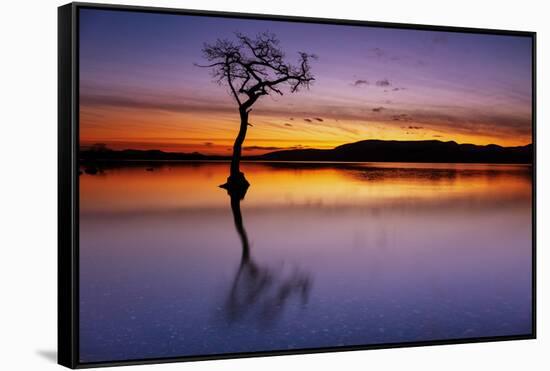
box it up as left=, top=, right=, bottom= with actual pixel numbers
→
left=58, top=3, right=536, bottom=368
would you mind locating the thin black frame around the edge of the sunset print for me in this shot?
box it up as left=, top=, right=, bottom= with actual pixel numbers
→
left=58, top=3, right=537, bottom=368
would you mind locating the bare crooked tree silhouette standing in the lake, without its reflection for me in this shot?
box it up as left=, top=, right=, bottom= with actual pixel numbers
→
left=198, top=32, right=316, bottom=190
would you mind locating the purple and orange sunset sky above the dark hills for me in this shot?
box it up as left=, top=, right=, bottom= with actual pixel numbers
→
left=80, top=9, right=532, bottom=154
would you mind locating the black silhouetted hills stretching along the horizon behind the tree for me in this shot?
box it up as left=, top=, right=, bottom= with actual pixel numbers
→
left=80, top=140, right=533, bottom=163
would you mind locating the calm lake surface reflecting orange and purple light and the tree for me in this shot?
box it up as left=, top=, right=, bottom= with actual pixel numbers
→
left=80, top=162, right=532, bottom=362
